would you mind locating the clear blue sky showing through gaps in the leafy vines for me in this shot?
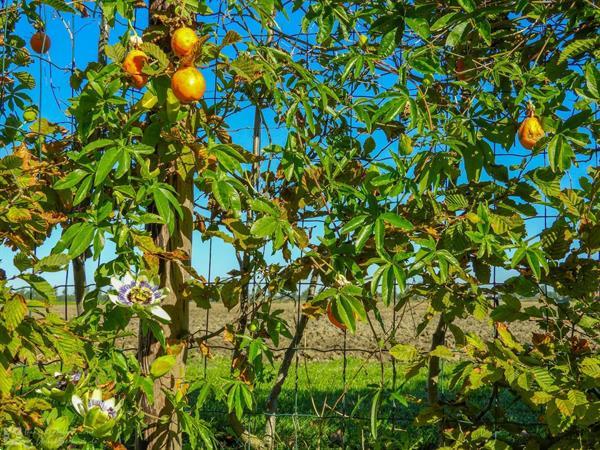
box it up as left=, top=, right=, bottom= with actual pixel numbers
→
left=0, top=2, right=596, bottom=292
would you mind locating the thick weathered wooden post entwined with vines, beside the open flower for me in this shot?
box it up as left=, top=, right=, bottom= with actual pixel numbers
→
left=136, top=0, right=194, bottom=450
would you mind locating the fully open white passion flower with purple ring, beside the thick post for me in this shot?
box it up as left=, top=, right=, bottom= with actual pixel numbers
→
left=108, top=275, right=171, bottom=321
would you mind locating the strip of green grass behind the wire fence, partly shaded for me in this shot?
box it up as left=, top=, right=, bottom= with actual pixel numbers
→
left=188, top=357, right=535, bottom=449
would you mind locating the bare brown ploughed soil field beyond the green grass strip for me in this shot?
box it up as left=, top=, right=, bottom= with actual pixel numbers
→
left=55, top=301, right=539, bottom=360
